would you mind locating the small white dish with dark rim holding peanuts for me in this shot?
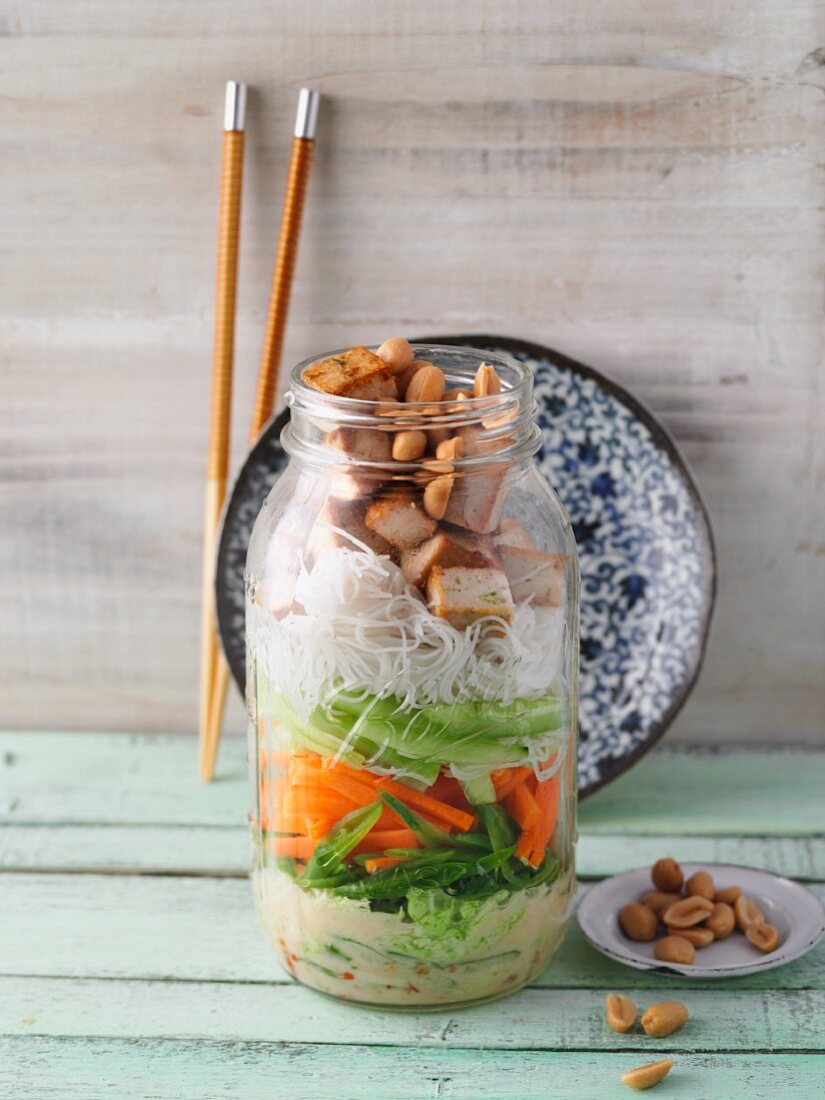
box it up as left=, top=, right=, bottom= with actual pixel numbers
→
left=576, top=864, right=825, bottom=980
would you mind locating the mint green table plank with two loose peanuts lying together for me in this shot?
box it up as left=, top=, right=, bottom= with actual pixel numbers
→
left=0, top=978, right=825, bottom=1058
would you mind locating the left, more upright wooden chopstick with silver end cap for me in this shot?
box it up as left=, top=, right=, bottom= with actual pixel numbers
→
left=198, top=80, right=246, bottom=774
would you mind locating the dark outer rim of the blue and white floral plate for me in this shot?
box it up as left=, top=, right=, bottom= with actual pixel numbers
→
left=216, top=333, right=717, bottom=800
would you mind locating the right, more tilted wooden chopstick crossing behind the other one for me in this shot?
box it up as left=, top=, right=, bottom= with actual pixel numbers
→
left=201, top=88, right=320, bottom=781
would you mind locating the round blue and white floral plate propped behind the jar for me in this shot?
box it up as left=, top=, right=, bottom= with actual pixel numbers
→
left=216, top=336, right=716, bottom=798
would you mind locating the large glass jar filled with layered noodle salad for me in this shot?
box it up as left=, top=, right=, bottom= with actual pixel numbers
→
left=246, top=345, right=579, bottom=1010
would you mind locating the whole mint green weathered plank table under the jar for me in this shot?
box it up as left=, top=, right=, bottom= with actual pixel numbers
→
left=0, top=734, right=825, bottom=1100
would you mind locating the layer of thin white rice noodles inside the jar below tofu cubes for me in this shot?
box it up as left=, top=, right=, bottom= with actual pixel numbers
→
left=257, top=540, right=564, bottom=717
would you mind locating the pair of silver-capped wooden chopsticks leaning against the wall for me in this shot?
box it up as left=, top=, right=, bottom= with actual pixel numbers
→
left=198, top=81, right=320, bottom=781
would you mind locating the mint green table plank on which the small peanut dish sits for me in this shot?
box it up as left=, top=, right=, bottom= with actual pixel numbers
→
left=0, top=873, right=825, bottom=990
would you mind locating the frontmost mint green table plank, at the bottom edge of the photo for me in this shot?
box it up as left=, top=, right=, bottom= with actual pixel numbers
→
left=0, top=1037, right=823, bottom=1100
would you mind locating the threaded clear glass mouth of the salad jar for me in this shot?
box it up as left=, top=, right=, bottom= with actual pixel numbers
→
left=283, top=343, right=541, bottom=470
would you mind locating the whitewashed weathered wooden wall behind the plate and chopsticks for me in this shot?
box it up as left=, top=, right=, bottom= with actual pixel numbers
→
left=0, top=0, right=825, bottom=741
